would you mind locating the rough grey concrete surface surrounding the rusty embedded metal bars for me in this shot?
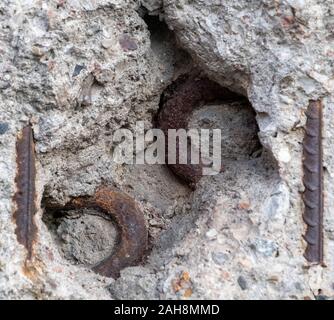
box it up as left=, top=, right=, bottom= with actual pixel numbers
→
left=0, top=0, right=334, bottom=299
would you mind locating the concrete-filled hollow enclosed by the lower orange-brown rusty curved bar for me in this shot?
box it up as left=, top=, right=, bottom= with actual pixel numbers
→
left=43, top=201, right=119, bottom=267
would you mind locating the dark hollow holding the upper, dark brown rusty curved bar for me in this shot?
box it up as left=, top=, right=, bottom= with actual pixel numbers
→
left=156, top=70, right=268, bottom=184
